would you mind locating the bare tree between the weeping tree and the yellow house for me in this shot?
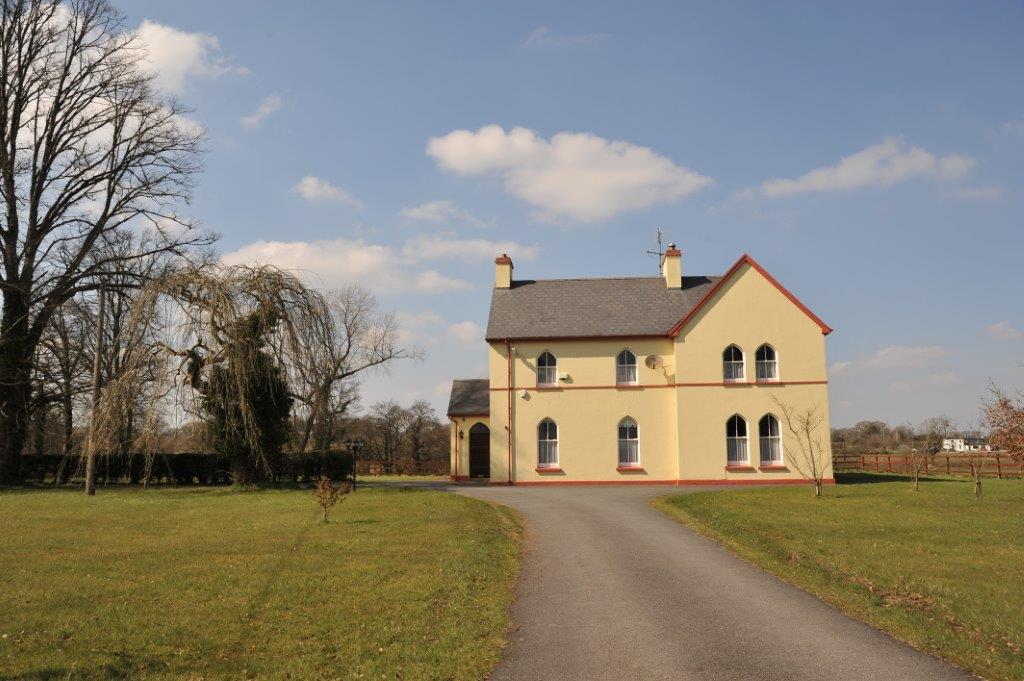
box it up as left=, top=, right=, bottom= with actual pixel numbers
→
left=291, top=286, right=421, bottom=452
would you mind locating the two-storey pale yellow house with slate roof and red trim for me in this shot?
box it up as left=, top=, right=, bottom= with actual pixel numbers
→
left=449, top=245, right=833, bottom=484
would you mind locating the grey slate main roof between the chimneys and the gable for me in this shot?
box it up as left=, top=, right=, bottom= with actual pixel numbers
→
left=485, top=276, right=722, bottom=339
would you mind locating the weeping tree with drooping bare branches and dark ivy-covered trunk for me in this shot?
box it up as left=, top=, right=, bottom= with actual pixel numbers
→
left=86, top=265, right=332, bottom=484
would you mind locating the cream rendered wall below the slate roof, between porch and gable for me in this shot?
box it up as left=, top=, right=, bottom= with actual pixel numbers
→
left=489, top=337, right=679, bottom=482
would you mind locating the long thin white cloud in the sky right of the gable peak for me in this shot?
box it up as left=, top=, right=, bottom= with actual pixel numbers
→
left=753, top=137, right=975, bottom=199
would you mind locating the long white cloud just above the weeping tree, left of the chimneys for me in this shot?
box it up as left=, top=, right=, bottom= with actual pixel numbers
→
left=222, top=239, right=470, bottom=294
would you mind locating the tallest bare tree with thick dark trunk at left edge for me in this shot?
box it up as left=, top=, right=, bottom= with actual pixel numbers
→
left=0, top=0, right=211, bottom=483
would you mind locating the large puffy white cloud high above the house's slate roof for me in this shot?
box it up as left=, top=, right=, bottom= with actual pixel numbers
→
left=427, top=125, right=713, bottom=222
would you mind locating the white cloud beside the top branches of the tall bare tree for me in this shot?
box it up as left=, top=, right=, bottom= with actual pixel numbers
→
left=135, top=19, right=250, bottom=94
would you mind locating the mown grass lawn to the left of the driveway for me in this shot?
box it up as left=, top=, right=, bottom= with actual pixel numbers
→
left=0, top=487, right=521, bottom=680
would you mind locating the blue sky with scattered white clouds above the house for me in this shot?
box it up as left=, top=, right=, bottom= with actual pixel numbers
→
left=118, top=0, right=1024, bottom=426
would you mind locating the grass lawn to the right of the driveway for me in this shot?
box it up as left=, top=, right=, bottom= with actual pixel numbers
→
left=654, top=474, right=1024, bottom=680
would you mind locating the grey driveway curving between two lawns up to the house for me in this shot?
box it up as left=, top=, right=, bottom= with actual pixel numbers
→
left=457, top=486, right=972, bottom=681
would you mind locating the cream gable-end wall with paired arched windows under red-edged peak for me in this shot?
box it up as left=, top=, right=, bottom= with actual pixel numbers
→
left=675, top=264, right=833, bottom=481
